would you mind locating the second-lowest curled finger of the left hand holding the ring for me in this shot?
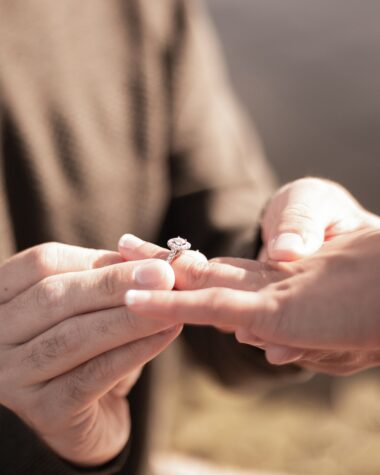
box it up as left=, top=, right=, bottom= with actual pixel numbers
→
left=17, top=306, right=171, bottom=385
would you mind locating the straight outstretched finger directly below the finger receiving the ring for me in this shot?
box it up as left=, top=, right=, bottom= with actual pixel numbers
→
left=125, top=288, right=273, bottom=328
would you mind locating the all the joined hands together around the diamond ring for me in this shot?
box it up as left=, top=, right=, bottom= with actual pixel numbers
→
left=0, top=180, right=380, bottom=465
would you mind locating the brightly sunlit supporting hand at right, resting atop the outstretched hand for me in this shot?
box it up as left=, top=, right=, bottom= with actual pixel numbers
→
left=260, top=178, right=380, bottom=261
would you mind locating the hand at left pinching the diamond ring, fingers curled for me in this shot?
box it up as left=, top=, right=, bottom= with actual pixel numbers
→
left=0, top=243, right=180, bottom=465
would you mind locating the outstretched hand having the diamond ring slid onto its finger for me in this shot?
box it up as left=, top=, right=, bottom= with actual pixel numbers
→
left=123, top=229, right=380, bottom=374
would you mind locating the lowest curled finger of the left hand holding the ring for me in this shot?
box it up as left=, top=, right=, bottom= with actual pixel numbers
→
left=44, top=326, right=182, bottom=413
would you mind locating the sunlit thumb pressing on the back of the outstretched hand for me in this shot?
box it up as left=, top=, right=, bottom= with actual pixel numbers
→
left=263, top=178, right=331, bottom=261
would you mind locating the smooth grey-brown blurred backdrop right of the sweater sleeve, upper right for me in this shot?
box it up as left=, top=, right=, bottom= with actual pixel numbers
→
left=206, top=0, right=380, bottom=212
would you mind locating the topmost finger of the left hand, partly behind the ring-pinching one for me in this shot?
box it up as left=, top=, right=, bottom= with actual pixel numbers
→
left=0, top=242, right=122, bottom=304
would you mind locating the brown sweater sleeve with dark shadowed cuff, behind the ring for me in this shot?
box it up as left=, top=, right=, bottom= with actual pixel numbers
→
left=161, top=0, right=299, bottom=385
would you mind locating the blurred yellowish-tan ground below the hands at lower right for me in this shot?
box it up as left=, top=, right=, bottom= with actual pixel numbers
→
left=166, top=371, right=380, bottom=475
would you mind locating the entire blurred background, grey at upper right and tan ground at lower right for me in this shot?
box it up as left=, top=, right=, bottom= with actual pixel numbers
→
left=166, top=0, right=380, bottom=475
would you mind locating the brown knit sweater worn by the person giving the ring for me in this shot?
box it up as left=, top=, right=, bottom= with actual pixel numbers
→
left=0, top=0, right=288, bottom=475
